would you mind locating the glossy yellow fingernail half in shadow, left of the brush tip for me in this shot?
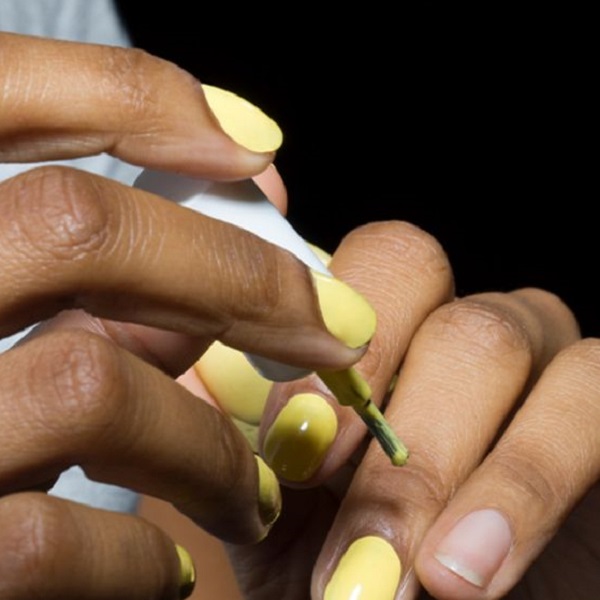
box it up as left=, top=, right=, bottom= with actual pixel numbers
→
left=263, top=394, right=337, bottom=482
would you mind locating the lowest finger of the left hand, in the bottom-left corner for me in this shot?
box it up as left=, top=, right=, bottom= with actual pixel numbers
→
left=0, top=493, right=193, bottom=600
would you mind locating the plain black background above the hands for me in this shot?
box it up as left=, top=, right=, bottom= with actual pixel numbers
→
left=113, top=0, right=600, bottom=336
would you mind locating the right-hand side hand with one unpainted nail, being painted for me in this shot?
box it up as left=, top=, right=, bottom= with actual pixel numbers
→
left=201, top=223, right=600, bottom=600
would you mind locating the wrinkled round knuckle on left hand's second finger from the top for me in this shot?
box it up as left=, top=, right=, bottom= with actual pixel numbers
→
left=5, top=167, right=111, bottom=261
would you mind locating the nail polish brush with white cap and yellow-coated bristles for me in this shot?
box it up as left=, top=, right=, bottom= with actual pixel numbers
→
left=134, top=170, right=408, bottom=466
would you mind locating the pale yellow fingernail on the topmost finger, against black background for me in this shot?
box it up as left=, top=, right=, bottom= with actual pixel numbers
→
left=202, top=85, right=283, bottom=152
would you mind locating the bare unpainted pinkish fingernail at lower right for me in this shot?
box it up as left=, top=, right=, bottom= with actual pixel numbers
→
left=435, top=509, right=512, bottom=588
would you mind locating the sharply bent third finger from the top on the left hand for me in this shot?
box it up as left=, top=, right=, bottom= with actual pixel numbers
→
left=0, top=331, right=279, bottom=541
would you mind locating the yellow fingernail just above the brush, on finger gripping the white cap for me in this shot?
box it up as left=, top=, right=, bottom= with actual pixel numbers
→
left=312, top=271, right=377, bottom=348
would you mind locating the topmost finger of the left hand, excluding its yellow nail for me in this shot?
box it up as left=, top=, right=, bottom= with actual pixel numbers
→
left=0, top=33, right=273, bottom=179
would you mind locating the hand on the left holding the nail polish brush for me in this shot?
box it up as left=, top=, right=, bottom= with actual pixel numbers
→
left=0, top=34, right=363, bottom=600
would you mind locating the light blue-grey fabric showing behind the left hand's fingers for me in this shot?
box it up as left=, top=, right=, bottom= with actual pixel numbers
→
left=0, top=0, right=140, bottom=512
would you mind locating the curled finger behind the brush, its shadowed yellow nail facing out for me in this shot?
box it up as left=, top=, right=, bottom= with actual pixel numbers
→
left=255, top=222, right=452, bottom=485
